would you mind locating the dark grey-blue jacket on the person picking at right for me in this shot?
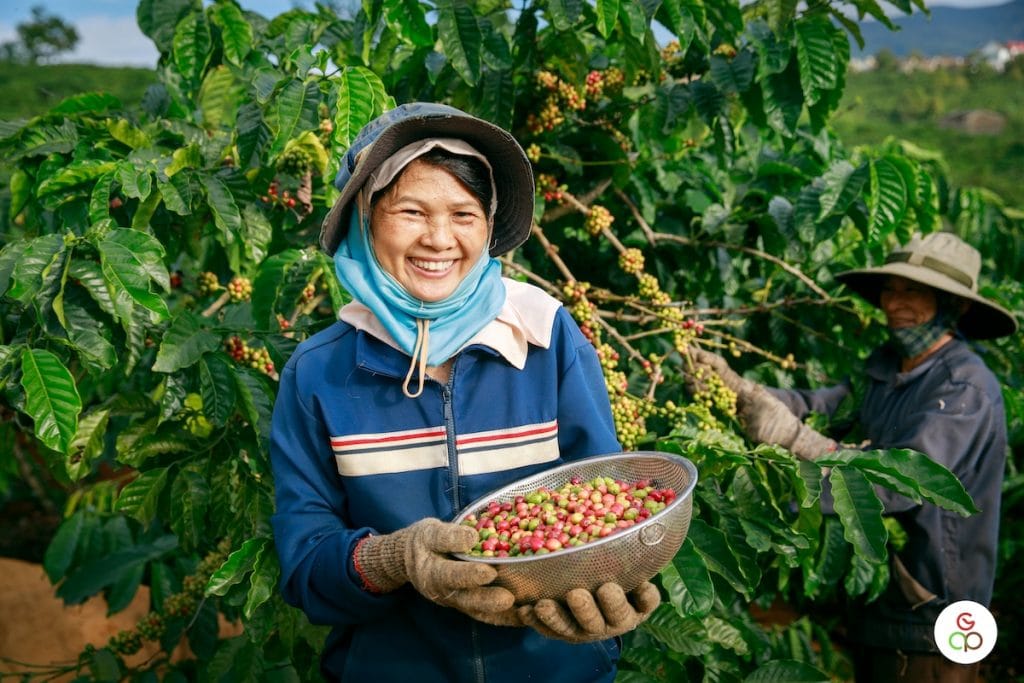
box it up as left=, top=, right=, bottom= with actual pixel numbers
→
left=772, top=339, right=1007, bottom=651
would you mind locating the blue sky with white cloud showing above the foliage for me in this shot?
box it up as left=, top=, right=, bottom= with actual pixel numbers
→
left=0, top=0, right=1008, bottom=67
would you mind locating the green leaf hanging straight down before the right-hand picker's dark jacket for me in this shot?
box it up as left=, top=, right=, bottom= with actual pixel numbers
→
left=828, top=466, right=889, bottom=562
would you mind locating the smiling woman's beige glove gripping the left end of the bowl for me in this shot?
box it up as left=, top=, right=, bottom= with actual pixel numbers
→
left=353, top=518, right=522, bottom=626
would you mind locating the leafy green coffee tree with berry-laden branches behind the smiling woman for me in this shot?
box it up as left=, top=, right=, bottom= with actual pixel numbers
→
left=0, top=0, right=1024, bottom=681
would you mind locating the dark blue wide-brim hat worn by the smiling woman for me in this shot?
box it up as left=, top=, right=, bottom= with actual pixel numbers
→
left=319, top=102, right=535, bottom=256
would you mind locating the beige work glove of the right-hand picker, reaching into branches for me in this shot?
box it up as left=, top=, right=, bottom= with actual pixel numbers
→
left=683, top=346, right=836, bottom=460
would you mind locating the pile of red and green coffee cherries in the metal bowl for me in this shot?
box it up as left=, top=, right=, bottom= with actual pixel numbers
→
left=462, top=477, right=676, bottom=557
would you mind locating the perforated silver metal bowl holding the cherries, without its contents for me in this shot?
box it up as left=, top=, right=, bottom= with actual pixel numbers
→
left=454, top=451, right=697, bottom=604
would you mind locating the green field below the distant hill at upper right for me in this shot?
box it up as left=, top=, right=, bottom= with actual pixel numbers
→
left=833, top=66, right=1024, bottom=207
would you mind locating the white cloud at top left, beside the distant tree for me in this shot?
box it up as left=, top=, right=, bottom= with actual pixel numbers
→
left=59, top=16, right=160, bottom=68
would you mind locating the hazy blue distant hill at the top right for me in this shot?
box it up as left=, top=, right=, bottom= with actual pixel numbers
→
left=851, top=0, right=1024, bottom=56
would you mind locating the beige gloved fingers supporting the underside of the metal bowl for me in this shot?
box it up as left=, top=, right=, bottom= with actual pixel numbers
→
left=519, top=582, right=662, bottom=643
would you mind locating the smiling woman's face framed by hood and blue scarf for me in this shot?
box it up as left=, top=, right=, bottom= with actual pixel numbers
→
left=370, top=159, right=488, bottom=302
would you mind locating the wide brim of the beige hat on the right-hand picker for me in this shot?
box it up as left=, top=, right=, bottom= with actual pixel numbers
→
left=836, top=262, right=1017, bottom=339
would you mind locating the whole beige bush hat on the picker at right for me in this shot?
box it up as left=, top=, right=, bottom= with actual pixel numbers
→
left=836, top=232, right=1017, bottom=339
